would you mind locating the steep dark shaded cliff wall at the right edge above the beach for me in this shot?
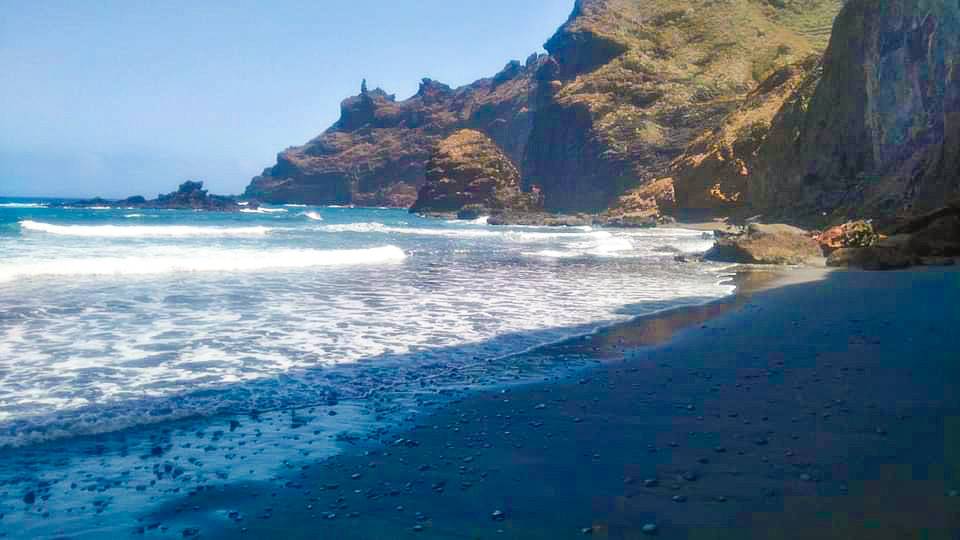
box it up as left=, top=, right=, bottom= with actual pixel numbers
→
left=749, top=0, right=960, bottom=222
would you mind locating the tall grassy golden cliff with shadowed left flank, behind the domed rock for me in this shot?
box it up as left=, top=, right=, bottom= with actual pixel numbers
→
left=523, top=0, right=840, bottom=213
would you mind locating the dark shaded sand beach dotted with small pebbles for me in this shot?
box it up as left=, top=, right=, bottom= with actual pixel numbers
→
left=124, top=270, right=960, bottom=539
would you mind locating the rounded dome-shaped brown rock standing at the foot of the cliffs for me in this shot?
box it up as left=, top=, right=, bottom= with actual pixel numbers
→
left=410, top=129, right=540, bottom=215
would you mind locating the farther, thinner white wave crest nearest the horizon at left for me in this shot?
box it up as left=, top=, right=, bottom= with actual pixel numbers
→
left=20, top=220, right=272, bottom=238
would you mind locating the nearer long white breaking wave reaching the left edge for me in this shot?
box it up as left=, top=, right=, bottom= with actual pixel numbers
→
left=0, top=246, right=406, bottom=282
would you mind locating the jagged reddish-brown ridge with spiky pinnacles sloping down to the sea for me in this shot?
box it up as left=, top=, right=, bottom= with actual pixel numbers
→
left=245, top=55, right=543, bottom=207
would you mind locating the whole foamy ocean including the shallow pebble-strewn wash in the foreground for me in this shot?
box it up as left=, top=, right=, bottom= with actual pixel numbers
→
left=0, top=199, right=733, bottom=537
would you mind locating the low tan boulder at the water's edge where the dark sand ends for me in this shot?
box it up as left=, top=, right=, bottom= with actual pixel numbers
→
left=705, top=224, right=823, bottom=264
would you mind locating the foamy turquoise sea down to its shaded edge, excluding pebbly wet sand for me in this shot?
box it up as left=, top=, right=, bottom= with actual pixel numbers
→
left=0, top=199, right=730, bottom=446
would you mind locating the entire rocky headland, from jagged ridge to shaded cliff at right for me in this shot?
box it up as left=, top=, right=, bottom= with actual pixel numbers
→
left=238, top=0, right=960, bottom=267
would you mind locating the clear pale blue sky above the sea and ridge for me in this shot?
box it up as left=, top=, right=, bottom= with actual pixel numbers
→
left=0, top=0, right=573, bottom=197
